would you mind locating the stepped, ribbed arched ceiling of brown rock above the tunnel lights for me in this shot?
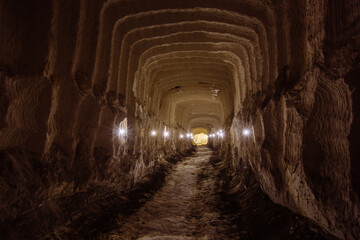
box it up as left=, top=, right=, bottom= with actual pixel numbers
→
left=92, top=0, right=288, bottom=130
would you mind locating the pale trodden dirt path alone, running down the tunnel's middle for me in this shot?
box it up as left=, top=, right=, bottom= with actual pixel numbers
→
left=102, top=147, right=236, bottom=239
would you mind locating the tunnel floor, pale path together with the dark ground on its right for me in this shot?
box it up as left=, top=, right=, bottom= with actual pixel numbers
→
left=99, top=146, right=333, bottom=240
